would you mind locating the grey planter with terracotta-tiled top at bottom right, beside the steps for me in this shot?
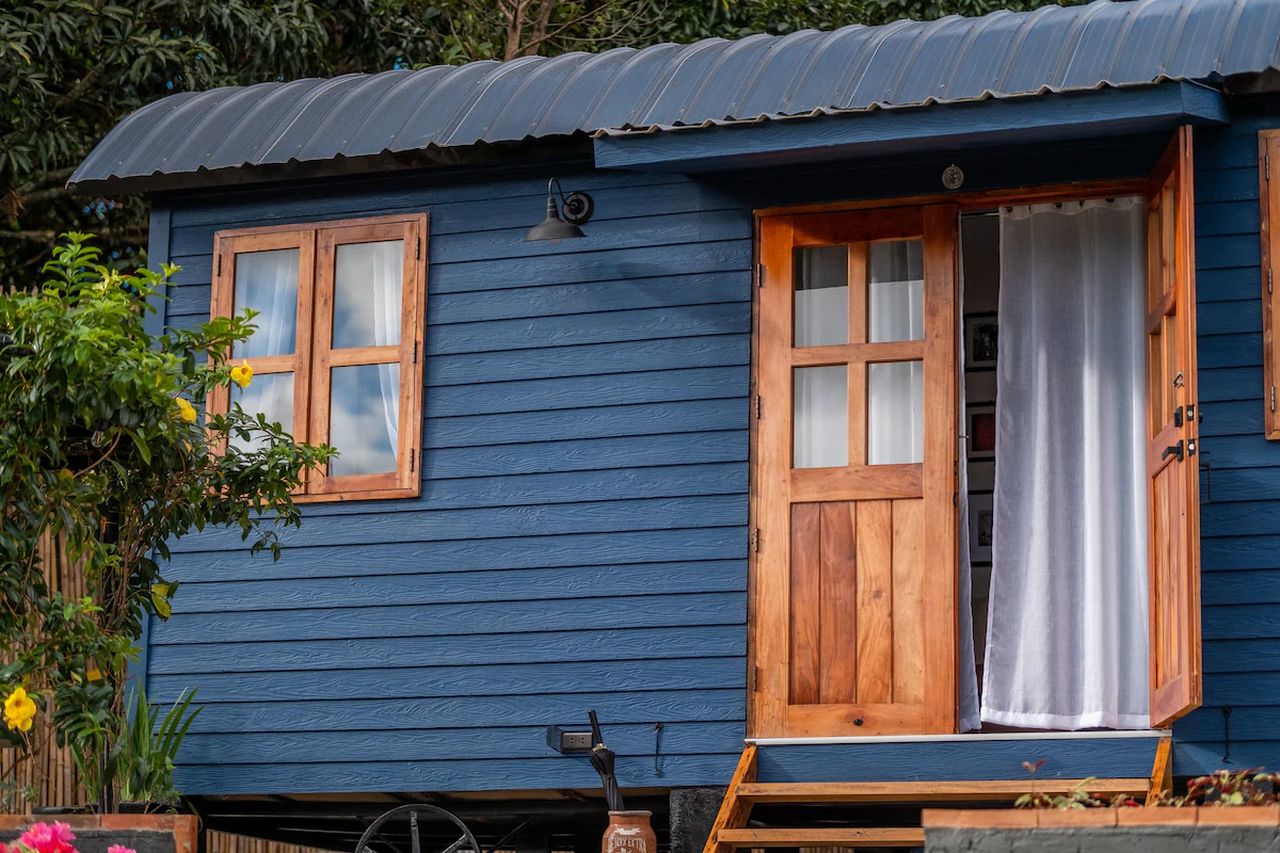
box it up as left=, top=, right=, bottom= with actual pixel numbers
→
left=922, top=806, right=1280, bottom=853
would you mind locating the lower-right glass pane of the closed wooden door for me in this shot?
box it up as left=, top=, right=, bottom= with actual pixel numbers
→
left=867, top=361, right=924, bottom=465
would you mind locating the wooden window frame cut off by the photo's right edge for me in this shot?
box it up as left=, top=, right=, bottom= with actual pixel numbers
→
left=1258, top=134, right=1280, bottom=441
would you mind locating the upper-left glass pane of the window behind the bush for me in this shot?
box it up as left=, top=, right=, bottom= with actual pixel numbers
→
left=232, top=248, right=298, bottom=359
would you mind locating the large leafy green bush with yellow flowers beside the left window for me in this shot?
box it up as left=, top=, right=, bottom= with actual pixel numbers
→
left=0, top=234, right=333, bottom=829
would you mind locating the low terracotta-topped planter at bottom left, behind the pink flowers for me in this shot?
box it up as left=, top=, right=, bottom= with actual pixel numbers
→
left=0, top=815, right=200, bottom=853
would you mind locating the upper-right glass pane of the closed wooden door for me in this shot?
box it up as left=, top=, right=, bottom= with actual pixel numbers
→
left=867, top=240, right=924, bottom=342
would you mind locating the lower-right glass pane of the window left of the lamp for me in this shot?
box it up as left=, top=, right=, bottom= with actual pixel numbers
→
left=329, top=364, right=399, bottom=476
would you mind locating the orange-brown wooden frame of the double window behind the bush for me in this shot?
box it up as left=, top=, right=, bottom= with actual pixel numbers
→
left=207, top=213, right=428, bottom=503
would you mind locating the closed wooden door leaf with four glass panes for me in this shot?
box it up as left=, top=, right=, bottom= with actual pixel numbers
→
left=750, top=205, right=959, bottom=738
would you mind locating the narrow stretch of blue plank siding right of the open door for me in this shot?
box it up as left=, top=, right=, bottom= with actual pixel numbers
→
left=1174, top=113, right=1280, bottom=774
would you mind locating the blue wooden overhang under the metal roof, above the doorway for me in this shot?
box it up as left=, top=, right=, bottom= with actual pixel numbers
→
left=594, top=82, right=1229, bottom=173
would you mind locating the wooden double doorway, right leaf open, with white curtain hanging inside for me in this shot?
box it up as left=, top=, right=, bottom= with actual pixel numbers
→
left=748, top=128, right=1199, bottom=739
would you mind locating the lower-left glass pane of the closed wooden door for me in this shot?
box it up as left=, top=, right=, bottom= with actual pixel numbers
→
left=792, top=364, right=849, bottom=467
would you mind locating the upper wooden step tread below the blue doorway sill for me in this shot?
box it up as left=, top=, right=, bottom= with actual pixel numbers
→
left=736, top=779, right=1151, bottom=804
